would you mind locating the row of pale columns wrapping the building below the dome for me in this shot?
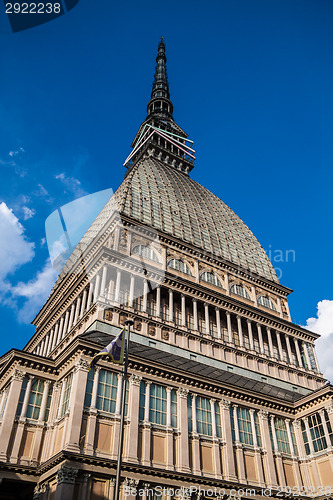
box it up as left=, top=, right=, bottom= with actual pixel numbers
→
left=34, top=265, right=319, bottom=372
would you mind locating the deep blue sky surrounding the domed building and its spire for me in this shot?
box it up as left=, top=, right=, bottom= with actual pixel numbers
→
left=0, top=0, right=333, bottom=376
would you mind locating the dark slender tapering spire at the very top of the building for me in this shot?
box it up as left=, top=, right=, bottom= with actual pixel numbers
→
left=147, top=37, right=173, bottom=117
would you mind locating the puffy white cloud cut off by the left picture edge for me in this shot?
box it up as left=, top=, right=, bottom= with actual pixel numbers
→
left=0, top=202, right=35, bottom=280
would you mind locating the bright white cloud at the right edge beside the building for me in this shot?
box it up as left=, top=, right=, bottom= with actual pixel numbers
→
left=306, top=299, right=333, bottom=381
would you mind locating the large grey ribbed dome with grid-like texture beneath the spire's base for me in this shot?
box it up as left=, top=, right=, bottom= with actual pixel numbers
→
left=116, top=157, right=278, bottom=282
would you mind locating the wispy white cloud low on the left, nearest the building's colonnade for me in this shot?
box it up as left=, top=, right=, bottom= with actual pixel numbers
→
left=12, top=259, right=58, bottom=323
